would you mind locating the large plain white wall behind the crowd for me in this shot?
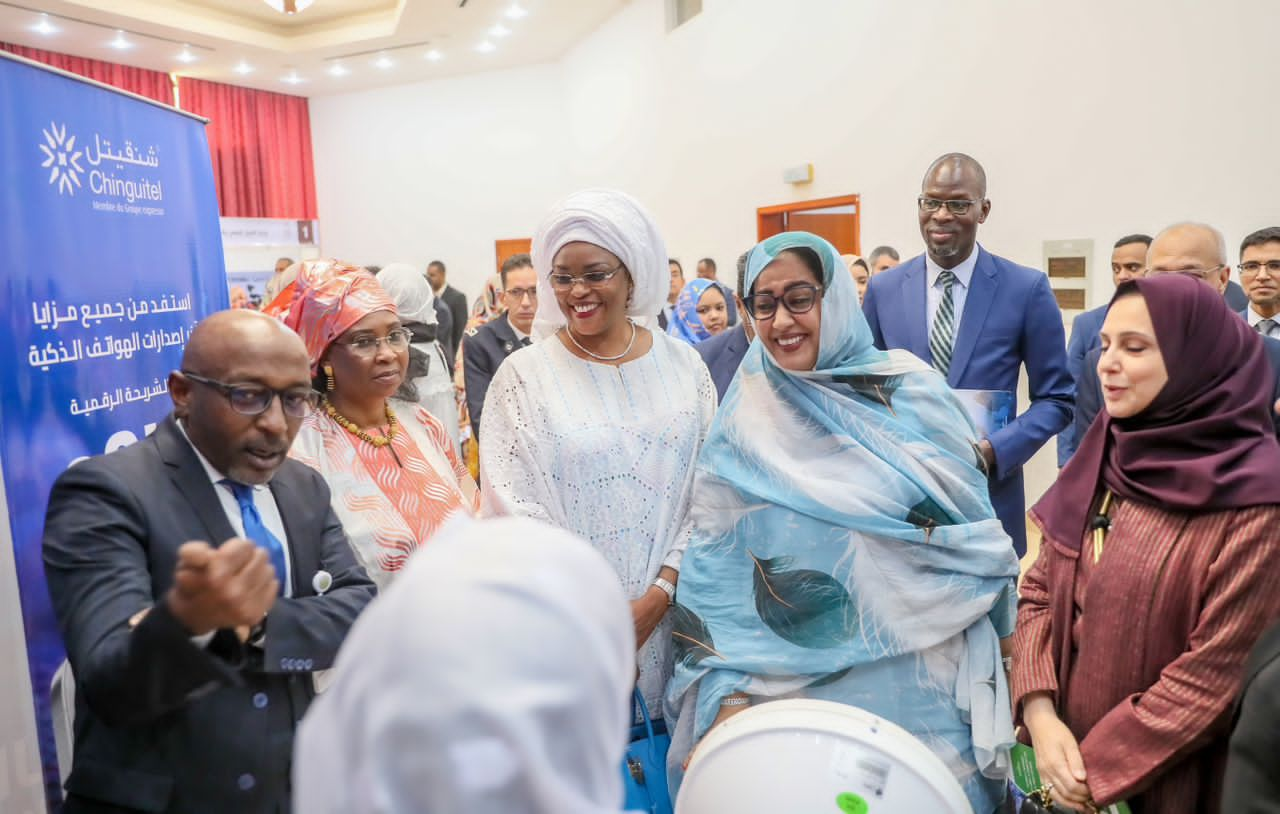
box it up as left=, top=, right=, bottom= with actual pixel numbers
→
left=311, top=0, right=1280, bottom=509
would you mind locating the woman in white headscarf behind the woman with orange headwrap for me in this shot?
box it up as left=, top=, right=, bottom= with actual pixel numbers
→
left=378, top=262, right=461, bottom=452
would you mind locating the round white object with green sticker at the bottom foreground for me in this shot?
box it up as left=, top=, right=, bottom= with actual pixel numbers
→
left=676, top=699, right=973, bottom=814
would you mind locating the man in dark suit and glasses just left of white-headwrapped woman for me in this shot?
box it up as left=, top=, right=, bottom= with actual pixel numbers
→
left=462, top=255, right=538, bottom=439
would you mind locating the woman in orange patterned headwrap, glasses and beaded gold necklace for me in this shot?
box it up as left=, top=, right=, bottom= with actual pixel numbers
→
left=273, top=260, right=479, bottom=589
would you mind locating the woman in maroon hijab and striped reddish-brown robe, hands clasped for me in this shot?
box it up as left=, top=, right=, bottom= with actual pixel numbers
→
left=1012, top=274, right=1280, bottom=814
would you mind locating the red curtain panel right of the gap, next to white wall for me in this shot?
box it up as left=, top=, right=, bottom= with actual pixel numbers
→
left=178, top=77, right=316, bottom=220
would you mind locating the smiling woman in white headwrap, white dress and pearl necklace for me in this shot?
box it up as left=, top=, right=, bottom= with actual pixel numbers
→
left=480, top=189, right=716, bottom=726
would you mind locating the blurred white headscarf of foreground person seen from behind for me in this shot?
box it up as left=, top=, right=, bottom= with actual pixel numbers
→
left=293, top=517, right=635, bottom=814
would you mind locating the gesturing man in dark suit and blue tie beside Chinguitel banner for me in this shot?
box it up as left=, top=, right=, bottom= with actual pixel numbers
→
left=44, top=311, right=374, bottom=814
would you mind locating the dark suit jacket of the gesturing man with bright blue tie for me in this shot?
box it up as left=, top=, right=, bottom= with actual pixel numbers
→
left=44, top=416, right=374, bottom=814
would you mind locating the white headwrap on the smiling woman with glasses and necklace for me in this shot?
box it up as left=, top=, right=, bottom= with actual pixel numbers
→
left=530, top=189, right=671, bottom=337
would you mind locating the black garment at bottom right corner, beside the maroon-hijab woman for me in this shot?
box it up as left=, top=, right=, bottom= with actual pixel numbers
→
left=1222, top=625, right=1280, bottom=814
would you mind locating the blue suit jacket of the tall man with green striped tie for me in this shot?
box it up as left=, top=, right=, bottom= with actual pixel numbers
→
left=863, top=246, right=1075, bottom=557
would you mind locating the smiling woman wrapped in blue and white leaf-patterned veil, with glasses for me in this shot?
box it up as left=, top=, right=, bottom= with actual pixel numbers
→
left=667, top=232, right=1018, bottom=814
